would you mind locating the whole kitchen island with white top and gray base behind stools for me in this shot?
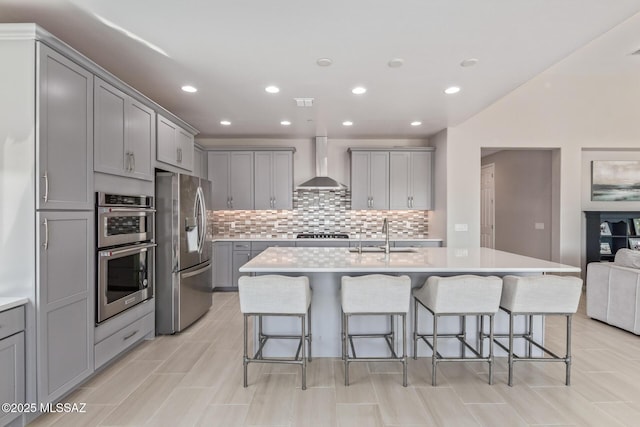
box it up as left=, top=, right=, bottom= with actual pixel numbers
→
left=240, top=247, right=580, bottom=357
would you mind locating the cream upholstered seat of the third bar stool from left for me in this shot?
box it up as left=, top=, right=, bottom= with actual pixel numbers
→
left=413, top=274, right=502, bottom=314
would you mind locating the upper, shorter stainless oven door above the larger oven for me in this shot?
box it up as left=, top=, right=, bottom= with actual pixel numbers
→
left=97, top=207, right=155, bottom=248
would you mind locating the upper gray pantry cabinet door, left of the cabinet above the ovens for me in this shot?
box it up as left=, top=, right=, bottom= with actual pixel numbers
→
left=36, top=43, right=94, bottom=209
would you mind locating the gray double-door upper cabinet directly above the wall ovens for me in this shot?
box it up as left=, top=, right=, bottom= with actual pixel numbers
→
left=94, top=77, right=156, bottom=181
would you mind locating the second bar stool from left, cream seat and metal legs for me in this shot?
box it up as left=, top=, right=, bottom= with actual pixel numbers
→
left=340, top=274, right=411, bottom=387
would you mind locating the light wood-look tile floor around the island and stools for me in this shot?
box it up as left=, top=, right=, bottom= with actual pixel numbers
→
left=31, top=293, right=640, bottom=427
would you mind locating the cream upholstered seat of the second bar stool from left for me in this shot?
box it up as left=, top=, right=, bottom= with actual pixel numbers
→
left=340, top=274, right=411, bottom=314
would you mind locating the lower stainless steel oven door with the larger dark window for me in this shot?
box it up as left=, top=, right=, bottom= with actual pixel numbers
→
left=97, top=243, right=156, bottom=323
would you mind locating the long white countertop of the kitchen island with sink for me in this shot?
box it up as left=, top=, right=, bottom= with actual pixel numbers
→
left=240, top=247, right=580, bottom=274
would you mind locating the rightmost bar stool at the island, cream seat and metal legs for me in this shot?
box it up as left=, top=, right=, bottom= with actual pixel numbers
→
left=496, top=275, right=582, bottom=386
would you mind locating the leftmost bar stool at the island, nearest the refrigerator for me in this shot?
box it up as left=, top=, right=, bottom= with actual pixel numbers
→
left=238, top=275, right=311, bottom=390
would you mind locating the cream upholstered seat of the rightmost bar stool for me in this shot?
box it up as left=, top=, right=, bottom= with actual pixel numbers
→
left=500, top=275, right=582, bottom=314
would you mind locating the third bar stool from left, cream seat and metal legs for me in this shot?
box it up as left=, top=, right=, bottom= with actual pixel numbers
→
left=413, top=275, right=502, bottom=386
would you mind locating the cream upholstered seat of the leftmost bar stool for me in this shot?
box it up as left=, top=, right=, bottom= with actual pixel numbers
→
left=238, top=274, right=311, bottom=314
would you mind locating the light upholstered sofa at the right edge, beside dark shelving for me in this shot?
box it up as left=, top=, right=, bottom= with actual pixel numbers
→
left=587, top=249, right=640, bottom=335
